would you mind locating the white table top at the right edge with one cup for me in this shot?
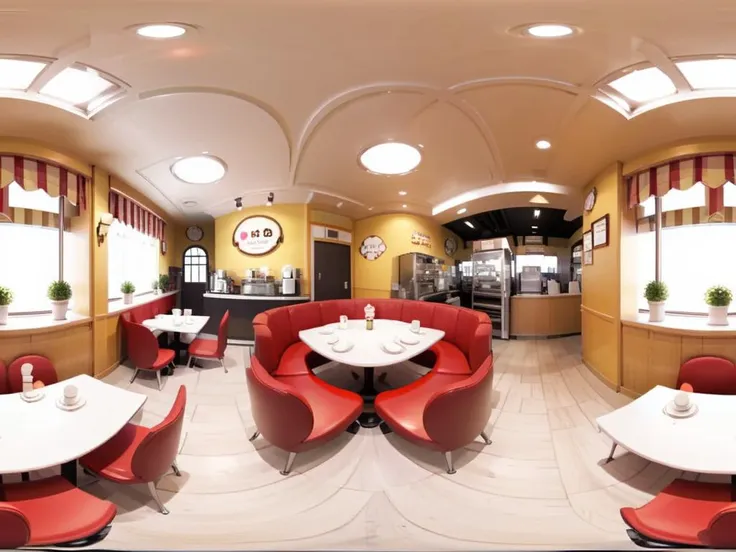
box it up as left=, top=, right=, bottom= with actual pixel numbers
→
left=597, top=385, right=736, bottom=475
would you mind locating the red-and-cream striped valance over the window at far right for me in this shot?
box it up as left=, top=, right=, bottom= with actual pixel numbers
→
left=628, top=153, right=736, bottom=215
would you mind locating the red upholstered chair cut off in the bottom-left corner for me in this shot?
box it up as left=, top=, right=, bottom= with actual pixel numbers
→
left=0, top=476, right=116, bottom=550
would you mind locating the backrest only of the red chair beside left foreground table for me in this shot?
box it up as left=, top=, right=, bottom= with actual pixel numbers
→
left=131, top=385, right=187, bottom=483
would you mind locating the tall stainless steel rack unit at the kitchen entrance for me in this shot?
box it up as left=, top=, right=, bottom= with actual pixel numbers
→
left=471, top=249, right=511, bottom=339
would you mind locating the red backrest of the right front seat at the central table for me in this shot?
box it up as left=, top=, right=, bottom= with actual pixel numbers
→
left=423, top=355, right=493, bottom=452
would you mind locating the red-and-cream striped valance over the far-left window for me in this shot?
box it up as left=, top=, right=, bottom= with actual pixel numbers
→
left=0, top=155, right=87, bottom=222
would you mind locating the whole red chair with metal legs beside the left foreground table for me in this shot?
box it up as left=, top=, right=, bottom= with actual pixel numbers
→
left=79, top=385, right=187, bottom=514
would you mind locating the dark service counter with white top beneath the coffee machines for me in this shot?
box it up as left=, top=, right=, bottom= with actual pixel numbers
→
left=202, top=293, right=309, bottom=341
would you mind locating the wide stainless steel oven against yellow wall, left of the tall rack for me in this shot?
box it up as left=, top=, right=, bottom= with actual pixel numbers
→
left=391, top=253, right=452, bottom=300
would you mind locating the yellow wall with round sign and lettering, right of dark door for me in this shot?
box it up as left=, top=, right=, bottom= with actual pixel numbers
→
left=353, top=214, right=470, bottom=297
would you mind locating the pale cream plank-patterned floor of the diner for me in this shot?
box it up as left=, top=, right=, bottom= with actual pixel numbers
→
left=28, top=338, right=720, bottom=550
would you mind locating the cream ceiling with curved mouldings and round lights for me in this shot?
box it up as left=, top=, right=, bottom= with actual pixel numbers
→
left=0, top=0, right=736, bottom=222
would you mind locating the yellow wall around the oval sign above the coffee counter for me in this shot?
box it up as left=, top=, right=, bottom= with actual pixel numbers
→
left=215, top=205, right=309, bottom=288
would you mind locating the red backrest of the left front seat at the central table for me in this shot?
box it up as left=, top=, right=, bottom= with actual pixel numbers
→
left=245, top=357, right=314, bottom=452
